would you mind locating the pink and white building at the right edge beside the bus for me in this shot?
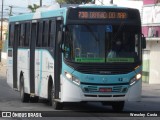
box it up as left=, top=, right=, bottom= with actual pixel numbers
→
left=142, top=0, right=160, bottom=84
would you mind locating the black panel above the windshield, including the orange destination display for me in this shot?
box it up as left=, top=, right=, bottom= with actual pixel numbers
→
left=67, top=8, right=140, bottom=24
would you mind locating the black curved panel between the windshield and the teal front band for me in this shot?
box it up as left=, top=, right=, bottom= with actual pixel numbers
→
left=65, top=61, right=140, bottom=75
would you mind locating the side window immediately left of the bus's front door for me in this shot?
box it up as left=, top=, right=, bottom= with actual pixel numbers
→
left=48, top=20, right=56, bottom=48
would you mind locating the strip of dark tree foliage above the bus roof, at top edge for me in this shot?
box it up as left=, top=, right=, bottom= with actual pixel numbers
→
left=56, top=0, right=93, bottom=4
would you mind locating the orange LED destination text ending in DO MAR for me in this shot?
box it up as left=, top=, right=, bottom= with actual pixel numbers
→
left=78, top=11, right=127, bottom=19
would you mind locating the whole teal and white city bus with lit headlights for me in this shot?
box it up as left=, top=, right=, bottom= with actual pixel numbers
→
left=7, top=5, right=146, bottom=111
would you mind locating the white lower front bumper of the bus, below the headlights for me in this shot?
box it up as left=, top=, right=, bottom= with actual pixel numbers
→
left=60, top=76, right=142, bottom=102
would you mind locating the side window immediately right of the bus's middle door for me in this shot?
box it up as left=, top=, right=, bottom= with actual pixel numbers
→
left=36, top=21, right=43, bottom=47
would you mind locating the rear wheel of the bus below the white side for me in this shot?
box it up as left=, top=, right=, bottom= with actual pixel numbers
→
left=20, top=76, right=30, bottom=102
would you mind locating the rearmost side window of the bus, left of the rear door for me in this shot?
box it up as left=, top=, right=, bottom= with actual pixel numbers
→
left=9, top=23, right=14, bottom=47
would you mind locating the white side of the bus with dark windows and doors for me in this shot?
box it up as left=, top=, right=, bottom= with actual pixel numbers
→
left=7, top=18, right=62, bottom=98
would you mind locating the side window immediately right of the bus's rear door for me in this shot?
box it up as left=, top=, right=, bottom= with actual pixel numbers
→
left=19, top=24, right=25, bottom=47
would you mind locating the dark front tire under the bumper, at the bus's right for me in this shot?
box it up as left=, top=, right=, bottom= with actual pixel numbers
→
left=112, top=101, right=125, bottom=112
